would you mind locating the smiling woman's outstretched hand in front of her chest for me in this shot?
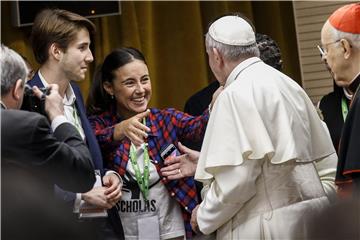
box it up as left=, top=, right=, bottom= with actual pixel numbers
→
left=114, top=110, right=150, bottom=146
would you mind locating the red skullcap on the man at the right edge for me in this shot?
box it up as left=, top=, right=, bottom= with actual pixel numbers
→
left=329, top=3, right=360, bottom=34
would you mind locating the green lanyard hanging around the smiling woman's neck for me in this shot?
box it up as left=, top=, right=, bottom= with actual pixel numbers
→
left=130, top=118, right=150, bottom=200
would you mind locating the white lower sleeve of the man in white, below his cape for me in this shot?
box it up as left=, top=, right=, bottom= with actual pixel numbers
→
left=197, top=160, right=263, bottom=234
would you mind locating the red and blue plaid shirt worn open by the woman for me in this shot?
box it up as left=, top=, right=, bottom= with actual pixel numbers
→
left=89, top=108, right=209, bottom=238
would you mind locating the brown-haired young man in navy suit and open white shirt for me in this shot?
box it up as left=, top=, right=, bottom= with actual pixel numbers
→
left=28, top=9, right=123, bottom=239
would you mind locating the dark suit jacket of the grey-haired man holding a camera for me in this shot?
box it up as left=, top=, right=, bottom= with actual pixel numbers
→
left=1, top=109, right=95, bottom=239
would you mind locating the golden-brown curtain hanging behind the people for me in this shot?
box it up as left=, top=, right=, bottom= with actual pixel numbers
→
left=1, top=1, right=301, bottom=110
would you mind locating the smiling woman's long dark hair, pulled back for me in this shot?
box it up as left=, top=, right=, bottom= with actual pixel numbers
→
left=87, top=47, right=146, bottom=115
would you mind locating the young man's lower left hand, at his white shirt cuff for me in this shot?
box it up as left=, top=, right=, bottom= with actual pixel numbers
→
left=81, top=187, right=114, bottom=209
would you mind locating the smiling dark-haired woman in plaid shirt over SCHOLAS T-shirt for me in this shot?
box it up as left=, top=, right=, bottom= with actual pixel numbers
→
left=88, top=48, right=209, bottom=239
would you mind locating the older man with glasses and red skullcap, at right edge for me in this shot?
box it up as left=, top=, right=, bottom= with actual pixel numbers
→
left=321, top=3, right=360, bottom=195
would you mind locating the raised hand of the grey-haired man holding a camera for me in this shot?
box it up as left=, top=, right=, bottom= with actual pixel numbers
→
left=33, top=84, right=64, bottom=122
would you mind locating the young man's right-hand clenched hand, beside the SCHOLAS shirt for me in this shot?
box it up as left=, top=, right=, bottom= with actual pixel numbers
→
left=103, top=173, right=122, bottom=206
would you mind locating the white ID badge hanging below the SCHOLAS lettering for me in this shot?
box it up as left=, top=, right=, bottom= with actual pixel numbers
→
left=138, top=215, right=160, bottom=240
